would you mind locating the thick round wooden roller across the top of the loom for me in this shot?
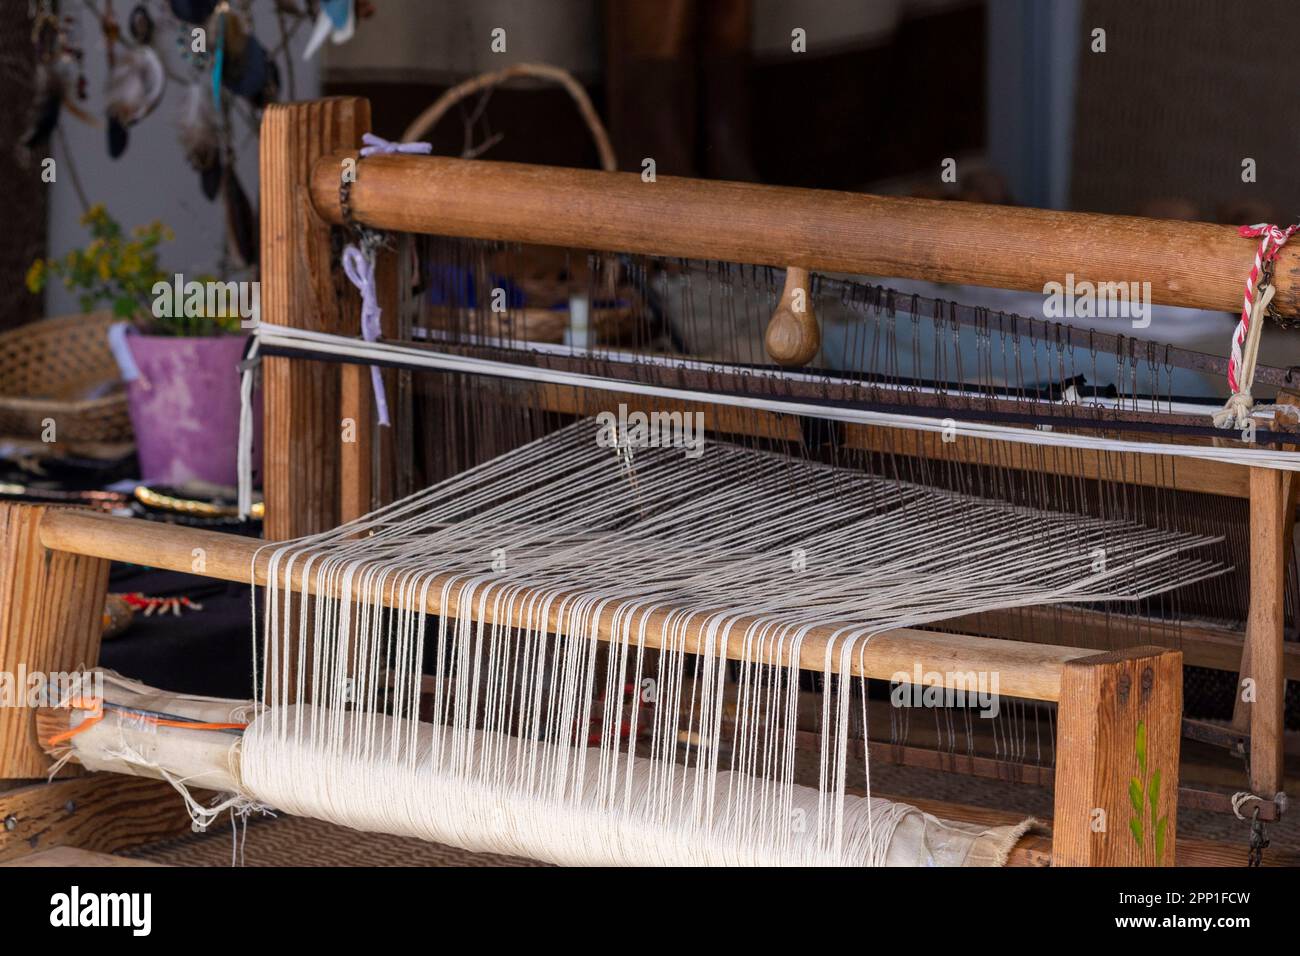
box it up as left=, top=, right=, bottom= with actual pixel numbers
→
left=306, top=153, right=1300, bottom=315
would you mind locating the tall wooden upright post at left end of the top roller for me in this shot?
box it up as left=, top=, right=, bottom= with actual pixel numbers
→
left=260, top=96, right=371, bottom=540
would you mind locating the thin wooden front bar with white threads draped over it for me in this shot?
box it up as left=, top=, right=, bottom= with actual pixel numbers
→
left=42, top=512, right=1091, bottom=700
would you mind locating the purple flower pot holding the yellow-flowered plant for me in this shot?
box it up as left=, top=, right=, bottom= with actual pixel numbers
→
left=126, top=334, right=261, bottom=486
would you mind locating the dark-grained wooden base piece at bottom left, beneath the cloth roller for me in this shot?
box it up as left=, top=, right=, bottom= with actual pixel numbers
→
left=0, top=774, right=197, bottom=861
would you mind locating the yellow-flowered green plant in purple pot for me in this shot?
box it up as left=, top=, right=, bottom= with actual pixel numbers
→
left=27, top=204, right=260, bottom=486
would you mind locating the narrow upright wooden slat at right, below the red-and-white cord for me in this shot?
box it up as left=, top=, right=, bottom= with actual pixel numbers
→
left=1238, top=468, right=1292, bottom=797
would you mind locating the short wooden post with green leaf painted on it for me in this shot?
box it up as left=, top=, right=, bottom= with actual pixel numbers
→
left=1052, top=648, right=1183, bottom=866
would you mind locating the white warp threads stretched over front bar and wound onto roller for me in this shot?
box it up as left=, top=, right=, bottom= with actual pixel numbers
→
left=241, top=420, right=1226, bottom=865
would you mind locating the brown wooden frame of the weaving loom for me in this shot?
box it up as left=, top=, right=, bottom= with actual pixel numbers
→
left=0, top=98, right=1300, bottom=865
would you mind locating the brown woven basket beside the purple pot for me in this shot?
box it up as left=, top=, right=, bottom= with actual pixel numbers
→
left=0, top=312, right=131, bottom=444
